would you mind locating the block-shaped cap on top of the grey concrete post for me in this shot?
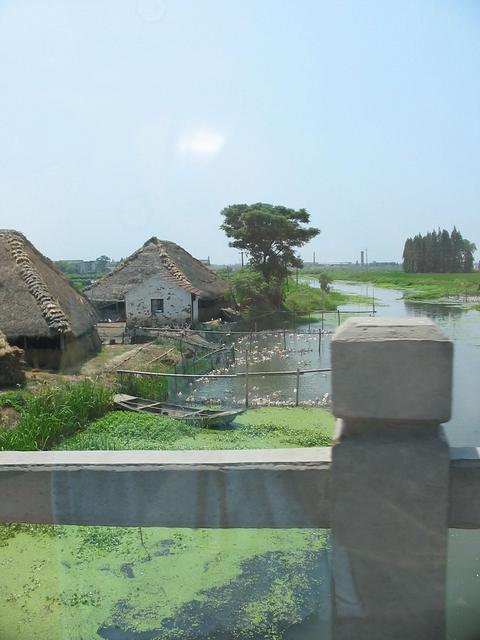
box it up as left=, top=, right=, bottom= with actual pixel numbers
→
left=332, top=318, right=453, bottom=422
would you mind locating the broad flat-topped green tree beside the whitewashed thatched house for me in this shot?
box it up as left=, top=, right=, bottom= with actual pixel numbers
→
left=221, top=202, right=320, bottom=284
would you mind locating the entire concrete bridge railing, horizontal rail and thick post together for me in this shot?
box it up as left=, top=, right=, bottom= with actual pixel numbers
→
left=0, top=319, right=480, bottom=640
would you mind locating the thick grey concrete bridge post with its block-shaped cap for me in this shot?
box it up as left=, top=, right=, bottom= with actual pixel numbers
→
left=331, top=318, right=452, bottom=640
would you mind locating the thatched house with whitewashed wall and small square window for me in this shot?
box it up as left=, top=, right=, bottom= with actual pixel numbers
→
left=85, top=238, right=228, bottom=326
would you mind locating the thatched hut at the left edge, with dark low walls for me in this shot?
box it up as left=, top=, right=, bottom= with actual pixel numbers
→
left=0, top=230, right=99, bottom=367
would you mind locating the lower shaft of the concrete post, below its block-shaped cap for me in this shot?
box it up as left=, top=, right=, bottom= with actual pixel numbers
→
left=331, top=424, right=449, bottom=640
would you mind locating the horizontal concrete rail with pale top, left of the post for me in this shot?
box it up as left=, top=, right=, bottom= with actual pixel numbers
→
left=0, top=448, right=330, bottom=528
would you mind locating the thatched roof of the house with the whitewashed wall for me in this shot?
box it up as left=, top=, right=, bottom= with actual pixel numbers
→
left=85, top=238, right=228, bottom=302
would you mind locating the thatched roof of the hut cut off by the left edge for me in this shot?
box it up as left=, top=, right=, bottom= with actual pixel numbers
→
left=0, top=230, right=97, bottom=340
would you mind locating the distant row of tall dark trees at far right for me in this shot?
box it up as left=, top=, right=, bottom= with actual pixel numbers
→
left=403, top=227, right=476, bottom=273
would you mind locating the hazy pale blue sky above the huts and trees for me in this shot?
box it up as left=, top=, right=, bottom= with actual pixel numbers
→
left=0, top=0, right=480, bottom=262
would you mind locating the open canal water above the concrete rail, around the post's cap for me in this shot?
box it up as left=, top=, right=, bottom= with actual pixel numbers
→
left=182, top=282, right=480, bottom=447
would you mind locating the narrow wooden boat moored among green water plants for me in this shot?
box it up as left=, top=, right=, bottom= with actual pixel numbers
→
left=113, top=393, right=244, bottom=427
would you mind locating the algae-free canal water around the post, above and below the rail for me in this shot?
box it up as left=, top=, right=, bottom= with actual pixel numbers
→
left=181, top=282, right=480, bottom=640
